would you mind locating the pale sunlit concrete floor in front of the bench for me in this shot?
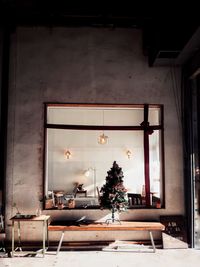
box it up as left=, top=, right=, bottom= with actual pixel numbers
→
left=0, top=249, right=200, bottom=267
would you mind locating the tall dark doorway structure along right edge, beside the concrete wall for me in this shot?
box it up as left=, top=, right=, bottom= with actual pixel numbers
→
left=181, top=50, right=200, bottom=247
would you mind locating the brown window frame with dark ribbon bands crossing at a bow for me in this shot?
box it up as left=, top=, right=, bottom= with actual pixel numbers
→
left=43, top=103, right=165, bottom=209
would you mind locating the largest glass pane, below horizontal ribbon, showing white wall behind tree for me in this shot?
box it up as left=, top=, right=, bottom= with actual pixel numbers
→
left=46, top=129, right=144, bottom=207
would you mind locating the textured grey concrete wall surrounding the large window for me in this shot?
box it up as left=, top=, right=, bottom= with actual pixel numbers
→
left=6, top=28, right=184, bottom=243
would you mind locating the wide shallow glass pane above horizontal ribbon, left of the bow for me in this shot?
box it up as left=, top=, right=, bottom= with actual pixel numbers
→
left=47, top=106, right=144, bottom=126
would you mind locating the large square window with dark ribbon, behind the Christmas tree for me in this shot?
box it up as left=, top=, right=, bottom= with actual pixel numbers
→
left=44, top=104, right=164, bottom=209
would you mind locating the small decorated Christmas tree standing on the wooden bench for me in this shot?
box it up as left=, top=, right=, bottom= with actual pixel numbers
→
left=100, top=161, right=128, bottom=222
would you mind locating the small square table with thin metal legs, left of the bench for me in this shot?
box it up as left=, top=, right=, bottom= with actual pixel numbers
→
left=10, top=215, right=50, bottom=257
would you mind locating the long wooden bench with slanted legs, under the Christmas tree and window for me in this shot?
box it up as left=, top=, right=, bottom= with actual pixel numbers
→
left=48, top=221, right=165, bottom=254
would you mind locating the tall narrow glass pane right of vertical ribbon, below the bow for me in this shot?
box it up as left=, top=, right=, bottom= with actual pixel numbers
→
left=149, top=131, right=162, bottom=208
